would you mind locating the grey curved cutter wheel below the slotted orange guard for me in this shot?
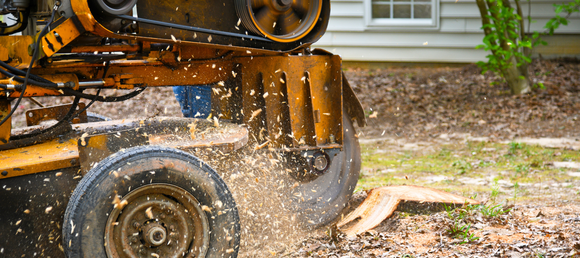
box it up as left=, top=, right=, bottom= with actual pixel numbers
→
left=292, top=110, right=361, bottom=228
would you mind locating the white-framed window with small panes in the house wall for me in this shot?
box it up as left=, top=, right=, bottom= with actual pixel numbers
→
left=366, top=0, right=439, bottom=29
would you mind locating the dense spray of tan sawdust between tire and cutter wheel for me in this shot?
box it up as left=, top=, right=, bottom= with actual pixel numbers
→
left=195, top=146, right=310, bottom=258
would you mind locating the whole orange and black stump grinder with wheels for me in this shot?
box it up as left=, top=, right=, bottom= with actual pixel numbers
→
left=0, top=0, right=365, bottom=258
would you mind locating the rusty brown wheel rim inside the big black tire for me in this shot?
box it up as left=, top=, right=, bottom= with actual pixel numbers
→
left=105, top=184, right=209, bottom=258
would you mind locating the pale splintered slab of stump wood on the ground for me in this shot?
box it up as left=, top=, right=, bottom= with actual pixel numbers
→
left=337, top=185, right=479, bottom=237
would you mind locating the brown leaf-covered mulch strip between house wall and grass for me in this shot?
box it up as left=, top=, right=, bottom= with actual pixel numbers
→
left=346, top=59, right=580, bottom=139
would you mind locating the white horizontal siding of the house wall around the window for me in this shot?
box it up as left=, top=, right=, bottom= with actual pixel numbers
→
left=314, top=0, right=580, bottom=63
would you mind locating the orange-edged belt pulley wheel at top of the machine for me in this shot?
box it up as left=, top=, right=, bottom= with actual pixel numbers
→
left=236, top=0, right=322, bottom=42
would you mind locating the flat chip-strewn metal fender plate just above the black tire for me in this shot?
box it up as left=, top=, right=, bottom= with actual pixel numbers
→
left=77, top=118, right=248, bottom=173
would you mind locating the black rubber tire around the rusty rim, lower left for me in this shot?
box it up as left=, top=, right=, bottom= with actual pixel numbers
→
left=62, top=146, right=240, bottom=258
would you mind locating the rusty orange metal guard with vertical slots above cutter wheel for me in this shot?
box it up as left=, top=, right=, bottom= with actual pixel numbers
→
left=237, top=55, right=342, bottom=148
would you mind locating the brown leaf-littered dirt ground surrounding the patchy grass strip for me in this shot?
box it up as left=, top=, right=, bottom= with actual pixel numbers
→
left=9, top=57, right=580, bottom=257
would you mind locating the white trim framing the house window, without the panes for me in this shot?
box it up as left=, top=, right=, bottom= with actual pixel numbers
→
left=364, top=0, right=440, bottom=31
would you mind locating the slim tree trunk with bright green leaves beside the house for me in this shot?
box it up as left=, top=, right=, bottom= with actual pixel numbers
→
left=476, top=0, right=580, bottom=94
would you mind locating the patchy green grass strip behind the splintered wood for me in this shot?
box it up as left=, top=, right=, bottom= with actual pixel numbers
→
left=357, top=141, right=580, bottom=198
